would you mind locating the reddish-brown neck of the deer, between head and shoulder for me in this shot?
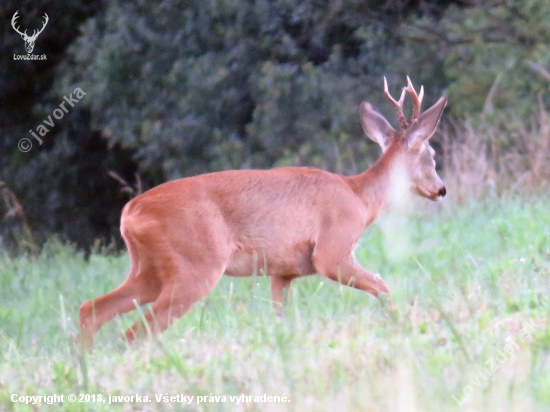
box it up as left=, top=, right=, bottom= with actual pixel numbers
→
left=349, top=144, right=403, bottom=224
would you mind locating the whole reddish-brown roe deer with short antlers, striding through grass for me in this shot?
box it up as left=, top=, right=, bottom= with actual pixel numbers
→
left=80, top=77, right=447, bottom=347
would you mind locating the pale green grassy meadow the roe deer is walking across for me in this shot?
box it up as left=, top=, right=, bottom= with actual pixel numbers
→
left=0, top=198, right=550, bottom=411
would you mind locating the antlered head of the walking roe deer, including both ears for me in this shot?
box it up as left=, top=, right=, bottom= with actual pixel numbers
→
left=361, top=76, right=447, bottom=200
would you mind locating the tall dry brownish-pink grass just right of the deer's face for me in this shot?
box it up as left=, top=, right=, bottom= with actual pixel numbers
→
left=440, top=100, right=550, bottom=203
